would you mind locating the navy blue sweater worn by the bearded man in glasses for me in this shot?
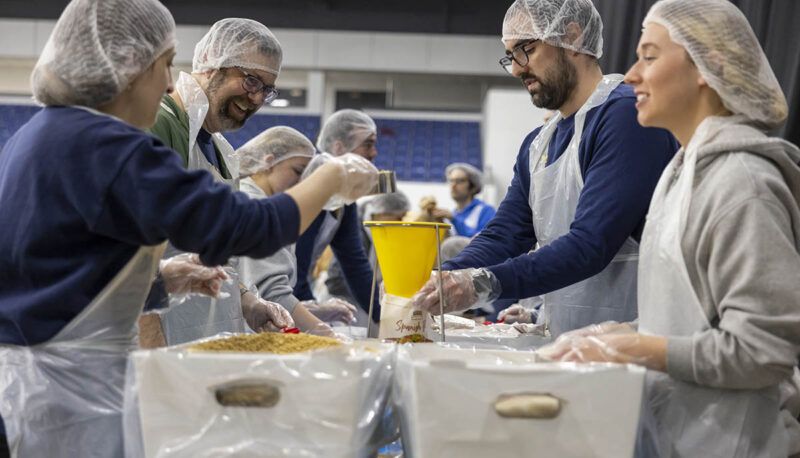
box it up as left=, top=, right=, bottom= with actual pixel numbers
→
left=442, top=84, right=678, bottom=299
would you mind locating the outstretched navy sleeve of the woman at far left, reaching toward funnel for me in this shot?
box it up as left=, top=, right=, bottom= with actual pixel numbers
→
left=87, top=141, right=300, bottom=265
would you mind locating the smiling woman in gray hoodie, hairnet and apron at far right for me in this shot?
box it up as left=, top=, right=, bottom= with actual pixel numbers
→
left=546, top=0, right=800, bottom=457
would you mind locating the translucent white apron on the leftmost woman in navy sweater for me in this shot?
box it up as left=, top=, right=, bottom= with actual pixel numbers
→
left=0, top=243, right=166, bottom=458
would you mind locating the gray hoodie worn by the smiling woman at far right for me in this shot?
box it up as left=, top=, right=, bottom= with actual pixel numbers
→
left=667, top=117, right=800, bottom=450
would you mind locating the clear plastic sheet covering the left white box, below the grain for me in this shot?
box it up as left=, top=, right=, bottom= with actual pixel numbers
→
left=125, top=334, right=396, bottom=458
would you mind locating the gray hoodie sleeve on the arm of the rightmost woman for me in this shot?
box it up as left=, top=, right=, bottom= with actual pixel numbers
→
left=667, top=198, right=800, bottom=389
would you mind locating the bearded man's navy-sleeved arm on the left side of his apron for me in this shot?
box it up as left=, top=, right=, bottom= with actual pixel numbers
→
left=442, top=134, right=538, bottom=270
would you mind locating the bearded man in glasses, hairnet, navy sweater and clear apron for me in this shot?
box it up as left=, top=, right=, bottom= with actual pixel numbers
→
left=414, top=0, right=678, bottom=335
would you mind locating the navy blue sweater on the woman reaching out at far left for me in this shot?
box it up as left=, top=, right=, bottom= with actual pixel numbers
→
left=0, top=107, right=300, bottom=345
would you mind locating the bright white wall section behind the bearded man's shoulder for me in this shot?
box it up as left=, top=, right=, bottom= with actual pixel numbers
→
left=481, top=85, right=547, bottom=205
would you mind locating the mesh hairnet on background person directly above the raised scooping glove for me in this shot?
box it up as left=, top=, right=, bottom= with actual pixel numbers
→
left=317, top=109, right=378, bottom=156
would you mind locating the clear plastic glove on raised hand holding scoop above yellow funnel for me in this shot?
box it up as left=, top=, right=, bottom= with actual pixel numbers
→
left=302, top=153, right=378, bottom=210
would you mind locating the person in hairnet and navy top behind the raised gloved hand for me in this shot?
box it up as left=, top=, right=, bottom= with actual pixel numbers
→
left=294, top=109, right=381, bottom=326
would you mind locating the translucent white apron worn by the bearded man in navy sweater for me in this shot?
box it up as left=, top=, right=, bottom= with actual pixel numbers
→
left=529, top=74, right=639, bottom=337
